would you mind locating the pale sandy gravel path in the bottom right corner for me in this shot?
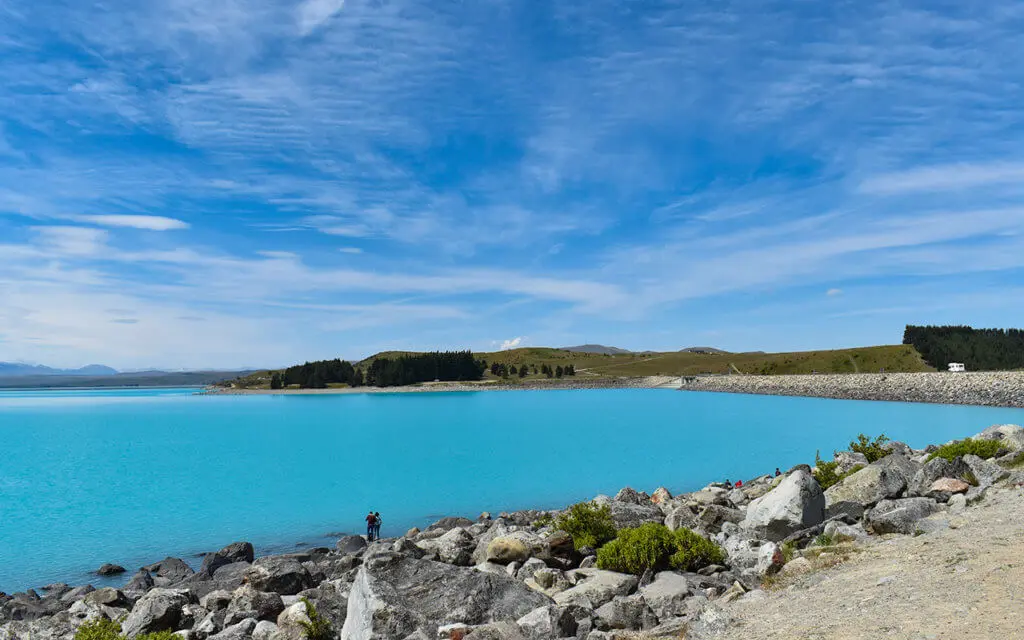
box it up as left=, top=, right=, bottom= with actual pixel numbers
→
left=721, top=487, right=1024, bottom=640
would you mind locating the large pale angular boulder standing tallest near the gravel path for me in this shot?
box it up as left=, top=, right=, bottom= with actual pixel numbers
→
left=741, top=469, right=825, bottom=542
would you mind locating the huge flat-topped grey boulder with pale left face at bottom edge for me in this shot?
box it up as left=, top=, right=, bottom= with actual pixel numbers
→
left=341, top=552, right=551, bottom=640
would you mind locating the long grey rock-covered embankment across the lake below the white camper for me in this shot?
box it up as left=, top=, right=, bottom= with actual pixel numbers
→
left=682, top=372, right=1024, bottom=408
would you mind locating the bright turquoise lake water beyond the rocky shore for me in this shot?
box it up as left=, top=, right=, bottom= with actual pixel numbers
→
left=0, top=389, right=1024, bottom=593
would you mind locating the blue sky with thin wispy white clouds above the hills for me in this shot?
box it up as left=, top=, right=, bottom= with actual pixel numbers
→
left=0, top=0, right=1024, bottom=369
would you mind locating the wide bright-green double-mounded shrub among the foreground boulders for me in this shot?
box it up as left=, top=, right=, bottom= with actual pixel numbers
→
left=597, top=522, right=725, bottom=575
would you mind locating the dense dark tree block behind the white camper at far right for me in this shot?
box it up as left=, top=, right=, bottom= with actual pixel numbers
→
left=903, top=325, right=1024, bottom=371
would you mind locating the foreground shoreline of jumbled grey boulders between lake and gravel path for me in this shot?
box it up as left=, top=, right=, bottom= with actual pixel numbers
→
left=0, top=425, right=1024, bottom=640
